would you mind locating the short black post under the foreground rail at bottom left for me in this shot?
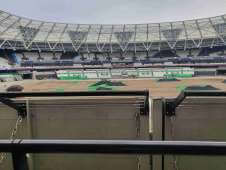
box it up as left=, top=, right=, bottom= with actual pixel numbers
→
left=12, top=152, right=29, bottom=170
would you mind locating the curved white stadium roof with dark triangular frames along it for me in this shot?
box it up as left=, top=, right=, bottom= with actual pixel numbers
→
left=0, top=11, right=226, bottom=52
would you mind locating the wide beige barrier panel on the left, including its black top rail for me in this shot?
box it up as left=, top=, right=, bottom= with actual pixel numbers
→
left=0, top=91, right=150, bottom=170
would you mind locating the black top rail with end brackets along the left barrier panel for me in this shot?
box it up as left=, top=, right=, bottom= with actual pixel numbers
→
left=0, top=90, right=149, bottom=117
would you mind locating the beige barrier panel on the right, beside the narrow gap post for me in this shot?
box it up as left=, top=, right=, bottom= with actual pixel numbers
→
left=150, top=90, right=226, bottom=170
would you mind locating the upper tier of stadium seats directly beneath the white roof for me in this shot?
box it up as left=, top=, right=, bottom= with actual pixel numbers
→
left=0, top=47, right=226, bottom=67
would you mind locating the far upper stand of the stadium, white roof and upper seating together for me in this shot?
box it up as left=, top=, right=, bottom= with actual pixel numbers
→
left=0, top=11, right=226, bottom=68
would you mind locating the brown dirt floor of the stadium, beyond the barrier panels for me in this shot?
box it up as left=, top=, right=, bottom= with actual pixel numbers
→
left=0, top=77, right=226, bottom=98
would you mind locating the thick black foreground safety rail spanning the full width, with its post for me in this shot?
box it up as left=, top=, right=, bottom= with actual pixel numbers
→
left=0, top=140, right=226, bottom=170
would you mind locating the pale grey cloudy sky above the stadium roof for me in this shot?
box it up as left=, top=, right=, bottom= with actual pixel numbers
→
left=0, top=0, right=226, bottom=24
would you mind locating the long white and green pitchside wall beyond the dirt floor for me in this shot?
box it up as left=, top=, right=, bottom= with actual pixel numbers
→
left=57, top=68, right=195, bottom=80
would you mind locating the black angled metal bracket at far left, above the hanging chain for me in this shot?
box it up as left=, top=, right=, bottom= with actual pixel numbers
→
left=0, top=97, right=27, bottom=118
